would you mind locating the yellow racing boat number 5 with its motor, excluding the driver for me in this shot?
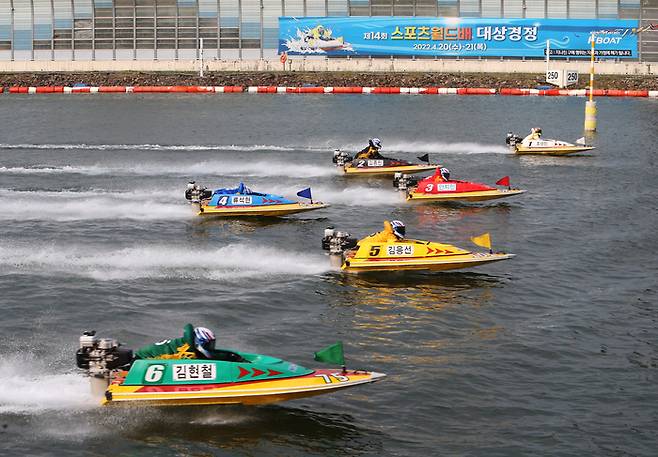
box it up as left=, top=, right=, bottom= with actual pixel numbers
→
left=322, top=227, right=514, bottom=273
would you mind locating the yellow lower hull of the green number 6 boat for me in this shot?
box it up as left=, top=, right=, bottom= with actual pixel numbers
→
left=102, top=369, right=386, bottom=406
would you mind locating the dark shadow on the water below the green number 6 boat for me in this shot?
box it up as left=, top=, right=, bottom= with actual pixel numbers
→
left=115, top=405, right=384, bottom=455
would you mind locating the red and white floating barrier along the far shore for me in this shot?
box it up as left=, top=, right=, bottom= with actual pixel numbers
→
left=5, top=86, right=658, bottom=98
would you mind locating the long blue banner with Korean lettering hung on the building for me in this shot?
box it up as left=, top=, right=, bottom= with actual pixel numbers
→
left=279, top=16, right=638, bottom=59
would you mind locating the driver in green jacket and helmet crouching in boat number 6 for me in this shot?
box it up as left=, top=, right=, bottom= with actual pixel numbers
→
left=135, top=324, right=216, bottom=359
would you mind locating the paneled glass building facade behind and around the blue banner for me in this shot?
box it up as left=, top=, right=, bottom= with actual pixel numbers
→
left=0, top=0, right=658, bottom=62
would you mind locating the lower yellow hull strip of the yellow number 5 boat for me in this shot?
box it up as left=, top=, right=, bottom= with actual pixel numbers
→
left=341, top=253, right=514, bottom=273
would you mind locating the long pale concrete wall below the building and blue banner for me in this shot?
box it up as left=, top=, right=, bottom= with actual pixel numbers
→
left=0, top=57, right=658, bottom=75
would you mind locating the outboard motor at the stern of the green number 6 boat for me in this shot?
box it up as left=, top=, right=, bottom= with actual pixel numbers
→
left=75, top=330, right=133, bottom=393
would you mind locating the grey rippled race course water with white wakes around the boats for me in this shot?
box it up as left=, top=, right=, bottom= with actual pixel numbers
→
left=0, top=94, right=658, bottom=456
